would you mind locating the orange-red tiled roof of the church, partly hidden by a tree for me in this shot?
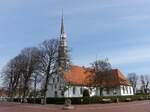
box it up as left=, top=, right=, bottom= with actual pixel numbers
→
left=63, top=65, right=131, bottom=87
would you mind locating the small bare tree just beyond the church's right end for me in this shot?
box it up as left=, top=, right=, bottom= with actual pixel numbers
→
left=127, top=73, right=139, bottom=93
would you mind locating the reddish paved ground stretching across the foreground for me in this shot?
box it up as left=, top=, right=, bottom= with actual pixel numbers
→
left=0, top=101, right=150, bottom=112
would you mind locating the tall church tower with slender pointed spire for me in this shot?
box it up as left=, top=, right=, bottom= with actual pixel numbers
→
left=58, top=13, right=69, bottom=70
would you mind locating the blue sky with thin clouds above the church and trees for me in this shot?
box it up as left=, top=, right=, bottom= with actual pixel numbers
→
left=0, top=0, right=150, bottom=77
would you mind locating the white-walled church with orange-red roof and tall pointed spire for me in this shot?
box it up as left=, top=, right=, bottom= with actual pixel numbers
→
left=46, top=16, right=134, bottom=97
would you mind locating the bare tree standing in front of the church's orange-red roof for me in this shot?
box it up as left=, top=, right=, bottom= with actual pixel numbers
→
left=92, top=59, right=111, bottom=96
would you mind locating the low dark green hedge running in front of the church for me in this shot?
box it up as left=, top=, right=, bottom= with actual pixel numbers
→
left=13, top=94, right=150, bottom=104
